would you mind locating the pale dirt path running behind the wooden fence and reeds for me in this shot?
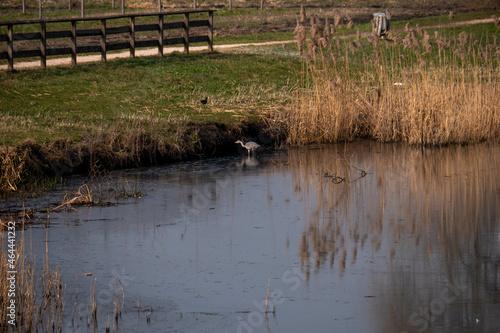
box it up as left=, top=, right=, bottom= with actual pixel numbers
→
left=0, top=19, right=493, bottom=70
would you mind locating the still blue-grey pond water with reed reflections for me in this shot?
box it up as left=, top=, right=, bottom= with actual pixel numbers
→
left=6, top=142, right=500, bottom=332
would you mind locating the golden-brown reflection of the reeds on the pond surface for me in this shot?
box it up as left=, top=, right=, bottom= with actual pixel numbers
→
left=289, top=143, right=500, bottom=331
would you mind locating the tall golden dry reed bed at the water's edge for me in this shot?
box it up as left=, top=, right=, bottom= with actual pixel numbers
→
left=287, top=7, right=500, bottom=145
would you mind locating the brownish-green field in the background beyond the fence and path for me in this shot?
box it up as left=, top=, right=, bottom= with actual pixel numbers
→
left=0, top=0, right=500, bottom=44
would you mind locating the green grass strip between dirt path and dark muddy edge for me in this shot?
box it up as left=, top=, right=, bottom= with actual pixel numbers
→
left=0, top=53, right=300, bottom=145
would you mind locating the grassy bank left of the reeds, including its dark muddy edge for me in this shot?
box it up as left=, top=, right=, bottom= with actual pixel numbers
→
left=0, top=53, right=300, bottom=191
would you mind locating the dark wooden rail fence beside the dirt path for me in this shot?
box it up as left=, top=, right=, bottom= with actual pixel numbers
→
left=0, top=9, right=215, bottom=70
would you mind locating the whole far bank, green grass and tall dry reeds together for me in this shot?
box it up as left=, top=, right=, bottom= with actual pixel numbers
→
left=0, top=8, right=500, bottom=196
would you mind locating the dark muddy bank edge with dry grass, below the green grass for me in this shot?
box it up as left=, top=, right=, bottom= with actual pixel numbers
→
left=0, top=122, right=283, bottom=196
